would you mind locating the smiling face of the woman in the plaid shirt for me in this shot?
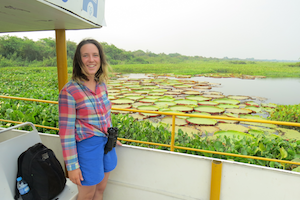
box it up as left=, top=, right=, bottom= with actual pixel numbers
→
left=80, top=43, right=101, bottom=78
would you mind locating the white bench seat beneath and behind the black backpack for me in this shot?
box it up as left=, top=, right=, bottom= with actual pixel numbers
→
left=0, top=122, right=78, bottom=200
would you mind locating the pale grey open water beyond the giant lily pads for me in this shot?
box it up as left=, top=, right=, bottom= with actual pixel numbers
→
left=122, top=74, right=300, bottom=105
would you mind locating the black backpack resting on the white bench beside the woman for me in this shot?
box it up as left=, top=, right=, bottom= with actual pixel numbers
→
left=15, top=143, right=66, bottom=200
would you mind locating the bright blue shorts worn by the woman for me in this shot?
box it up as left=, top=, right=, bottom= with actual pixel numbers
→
left=77, top=136, right=117, bottom=186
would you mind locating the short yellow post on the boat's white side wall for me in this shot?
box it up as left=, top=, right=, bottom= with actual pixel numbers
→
left=210, top=160, right=222, bottom=200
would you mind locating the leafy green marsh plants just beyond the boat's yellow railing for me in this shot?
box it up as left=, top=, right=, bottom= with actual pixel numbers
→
left=0, top=67, right=300, bottom=170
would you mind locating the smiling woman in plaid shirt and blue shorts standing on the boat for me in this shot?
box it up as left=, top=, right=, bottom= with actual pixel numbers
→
left=59, top=39, right=121, bottom=200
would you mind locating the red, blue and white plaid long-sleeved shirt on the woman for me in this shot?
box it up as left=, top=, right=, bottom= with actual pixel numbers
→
left=58, top=81, right=112, bottom=171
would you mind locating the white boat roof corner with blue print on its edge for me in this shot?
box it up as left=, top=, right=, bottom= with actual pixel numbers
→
left=0, top=0, right=105, bottom=33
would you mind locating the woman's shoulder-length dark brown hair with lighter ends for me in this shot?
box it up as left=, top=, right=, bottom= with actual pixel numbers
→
left=72, top=39, right=110, bottom=83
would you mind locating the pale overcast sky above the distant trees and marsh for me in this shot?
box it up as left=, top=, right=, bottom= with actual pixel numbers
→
left=0, top=0, right=300, bottom=60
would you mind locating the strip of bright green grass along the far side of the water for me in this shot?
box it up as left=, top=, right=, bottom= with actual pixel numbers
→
left=112, top=60, right=300, bottom=78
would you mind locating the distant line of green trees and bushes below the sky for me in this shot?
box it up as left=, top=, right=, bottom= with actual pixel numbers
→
left=0, top=35, right=212, bottom=67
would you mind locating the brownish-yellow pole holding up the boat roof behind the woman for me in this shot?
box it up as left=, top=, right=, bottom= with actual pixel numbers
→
left=55, top=29, right=68, bottom=91
